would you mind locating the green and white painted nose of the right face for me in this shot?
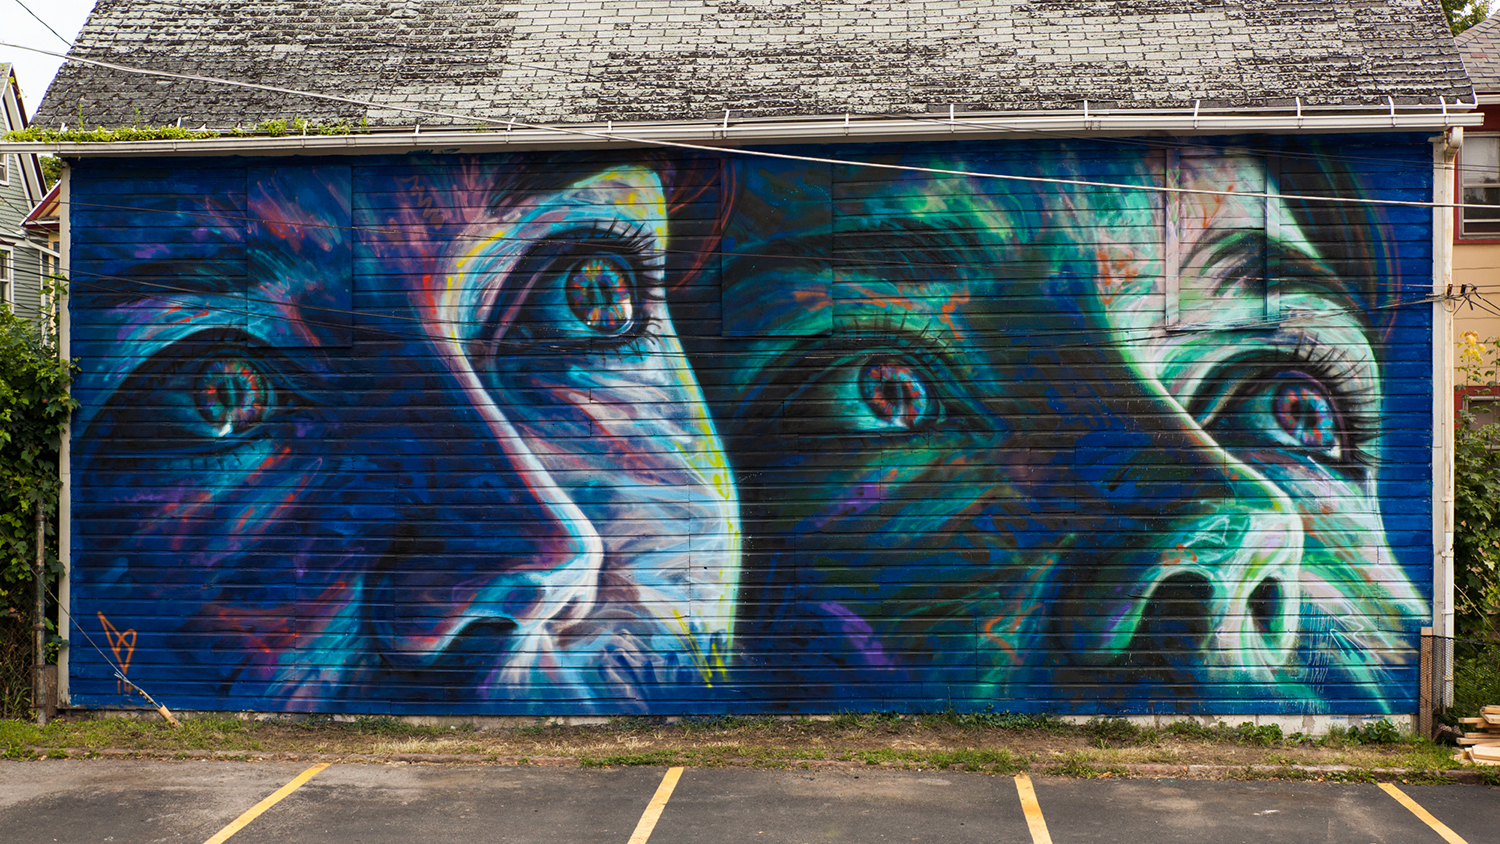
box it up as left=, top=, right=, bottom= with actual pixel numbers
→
left=1070, top=378, right=1304, bottom=681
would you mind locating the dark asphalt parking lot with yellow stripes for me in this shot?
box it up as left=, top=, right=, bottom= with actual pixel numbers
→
left=0, top=760, right=1500, bottom=844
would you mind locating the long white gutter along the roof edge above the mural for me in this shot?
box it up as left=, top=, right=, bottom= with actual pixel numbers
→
left=0, top=102, right=1484, bottom=157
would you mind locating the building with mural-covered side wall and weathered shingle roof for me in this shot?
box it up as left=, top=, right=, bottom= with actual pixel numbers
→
left=0, top=0, right=1479, bottom=729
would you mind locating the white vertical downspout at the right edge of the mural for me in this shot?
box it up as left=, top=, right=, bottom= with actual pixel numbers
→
left=1433, top=126, right=1464, bottom=709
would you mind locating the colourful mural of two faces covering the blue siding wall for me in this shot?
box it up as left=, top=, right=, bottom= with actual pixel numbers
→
left=71, top=139, right=1431, bottom=714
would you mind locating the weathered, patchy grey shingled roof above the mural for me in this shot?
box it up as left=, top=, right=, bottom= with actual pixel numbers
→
left=33, top=0, right=1488, bottom=127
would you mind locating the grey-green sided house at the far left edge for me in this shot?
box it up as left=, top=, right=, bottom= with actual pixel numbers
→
left=0, top=63, right=47, bottom=319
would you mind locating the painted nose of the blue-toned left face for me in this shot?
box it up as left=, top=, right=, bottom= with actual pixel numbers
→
left=368, top=359, right=605, bottom=669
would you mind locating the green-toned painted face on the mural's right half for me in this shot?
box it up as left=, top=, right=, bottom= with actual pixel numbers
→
left=701, top=153, right=1425, bottom=712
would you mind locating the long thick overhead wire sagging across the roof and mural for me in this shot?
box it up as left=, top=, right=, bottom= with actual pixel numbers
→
left=0, top=42, right=1464, bottom=215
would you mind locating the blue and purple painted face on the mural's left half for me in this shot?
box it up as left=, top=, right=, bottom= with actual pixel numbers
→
left=75, top=163, right=738, bottom=712
